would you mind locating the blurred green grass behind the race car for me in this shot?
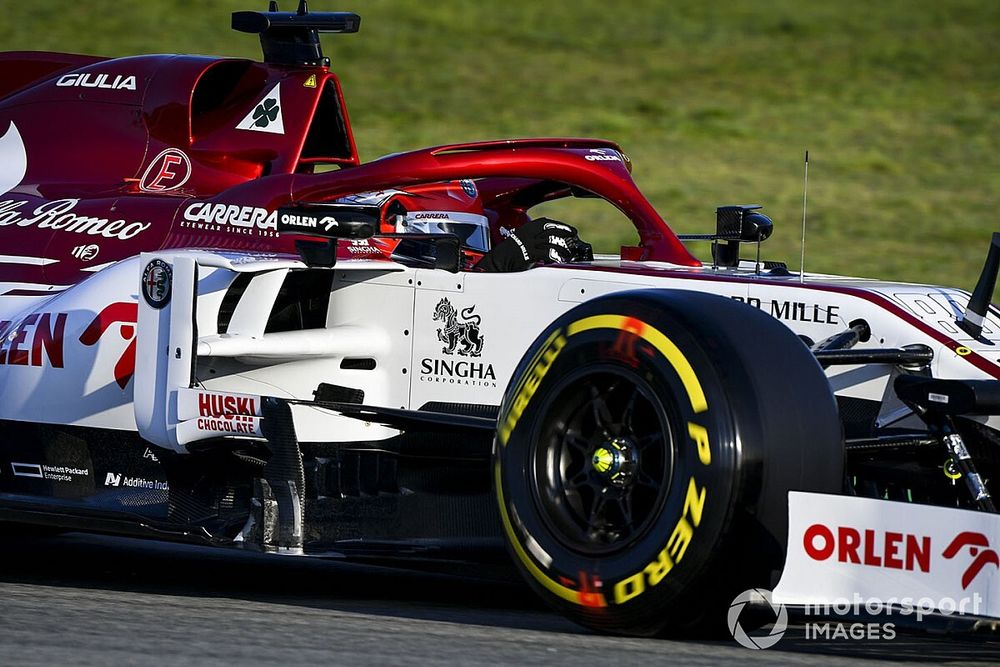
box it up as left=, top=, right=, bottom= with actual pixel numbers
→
left=0, top=0, right=1000, bottom=288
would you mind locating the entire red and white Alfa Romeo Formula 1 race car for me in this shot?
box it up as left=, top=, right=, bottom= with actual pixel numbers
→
left=0, top=3, right=1000, bottom=635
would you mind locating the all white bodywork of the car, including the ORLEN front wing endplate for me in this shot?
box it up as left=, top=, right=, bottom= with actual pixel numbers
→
left=0, top=250, right=1000, bottom=618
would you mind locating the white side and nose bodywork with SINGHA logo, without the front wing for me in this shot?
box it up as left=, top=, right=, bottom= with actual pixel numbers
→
left=0, top=251, right=1000, bottom=452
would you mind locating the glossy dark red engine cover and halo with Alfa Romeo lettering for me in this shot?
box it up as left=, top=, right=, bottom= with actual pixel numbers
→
left=0, top=53, right=699, bottom=285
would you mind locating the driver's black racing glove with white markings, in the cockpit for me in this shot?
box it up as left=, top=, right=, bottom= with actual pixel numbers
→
left=476, top=218, right=594, bottom=272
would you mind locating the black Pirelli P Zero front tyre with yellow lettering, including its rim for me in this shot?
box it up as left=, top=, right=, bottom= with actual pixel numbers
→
left=494, top=290, right=843, bottom=635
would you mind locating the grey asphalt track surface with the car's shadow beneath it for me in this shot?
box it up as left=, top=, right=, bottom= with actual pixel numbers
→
left=0, top=534, right=1000, bottom=667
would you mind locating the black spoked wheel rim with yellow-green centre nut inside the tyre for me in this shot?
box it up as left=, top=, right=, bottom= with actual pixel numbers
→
left=528, top=366, right=674, bottom=556
